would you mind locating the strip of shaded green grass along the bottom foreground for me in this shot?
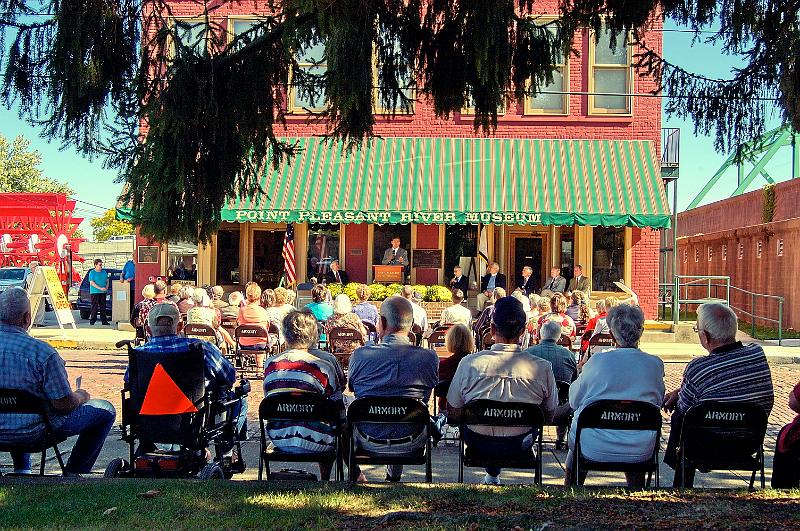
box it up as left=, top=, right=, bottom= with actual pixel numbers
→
left=0, top=479, right=800, bottom=529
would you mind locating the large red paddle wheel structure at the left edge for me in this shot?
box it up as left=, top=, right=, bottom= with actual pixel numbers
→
left=0, top=193, right=85, bottom=287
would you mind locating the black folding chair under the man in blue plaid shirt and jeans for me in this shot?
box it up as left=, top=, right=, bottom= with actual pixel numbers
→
left=0, top=389, right=64, bottom=476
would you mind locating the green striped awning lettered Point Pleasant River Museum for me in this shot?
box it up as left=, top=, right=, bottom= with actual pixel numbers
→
left=222, top=137, right=670, bottom=228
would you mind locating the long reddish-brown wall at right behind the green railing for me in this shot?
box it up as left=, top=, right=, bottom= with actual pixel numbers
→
left=678, top=179, right=800, bottom=330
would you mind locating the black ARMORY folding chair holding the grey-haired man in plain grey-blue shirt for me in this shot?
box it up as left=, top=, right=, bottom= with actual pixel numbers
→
left=347, top=396, right=433, bottom=483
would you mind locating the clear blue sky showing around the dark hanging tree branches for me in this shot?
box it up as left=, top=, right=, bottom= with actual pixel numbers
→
left=0, top=17, right=791, bottom=235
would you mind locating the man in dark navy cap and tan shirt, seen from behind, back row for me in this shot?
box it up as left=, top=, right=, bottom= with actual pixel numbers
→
left=447, top=297, right=558, bottom=485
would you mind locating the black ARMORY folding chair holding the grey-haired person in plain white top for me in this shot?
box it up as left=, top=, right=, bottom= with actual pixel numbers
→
left=573, top=400, right=661, bottom=488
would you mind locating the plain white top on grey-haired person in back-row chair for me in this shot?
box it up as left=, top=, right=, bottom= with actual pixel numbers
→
left=569, top=348, right=664, bottom=463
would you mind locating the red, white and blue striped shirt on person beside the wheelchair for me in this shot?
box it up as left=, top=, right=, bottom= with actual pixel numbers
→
left=264, top=349, right=342, bottom=452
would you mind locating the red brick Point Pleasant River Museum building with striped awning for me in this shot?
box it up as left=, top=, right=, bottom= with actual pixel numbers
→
left=133, top=1, right=669, bottom=318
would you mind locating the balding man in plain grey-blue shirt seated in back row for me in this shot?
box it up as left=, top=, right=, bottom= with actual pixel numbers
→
left=348, top=296, right=439, bottom=482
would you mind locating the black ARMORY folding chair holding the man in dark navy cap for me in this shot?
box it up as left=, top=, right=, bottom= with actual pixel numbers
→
left=458, top=399, right=544, bottom=485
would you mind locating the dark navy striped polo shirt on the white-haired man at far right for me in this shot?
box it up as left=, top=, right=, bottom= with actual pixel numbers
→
left=677, top=341, right=775, bottom=415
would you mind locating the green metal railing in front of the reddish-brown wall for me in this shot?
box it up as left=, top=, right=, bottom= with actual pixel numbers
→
left=658, top=275, right=784, bottom=345
